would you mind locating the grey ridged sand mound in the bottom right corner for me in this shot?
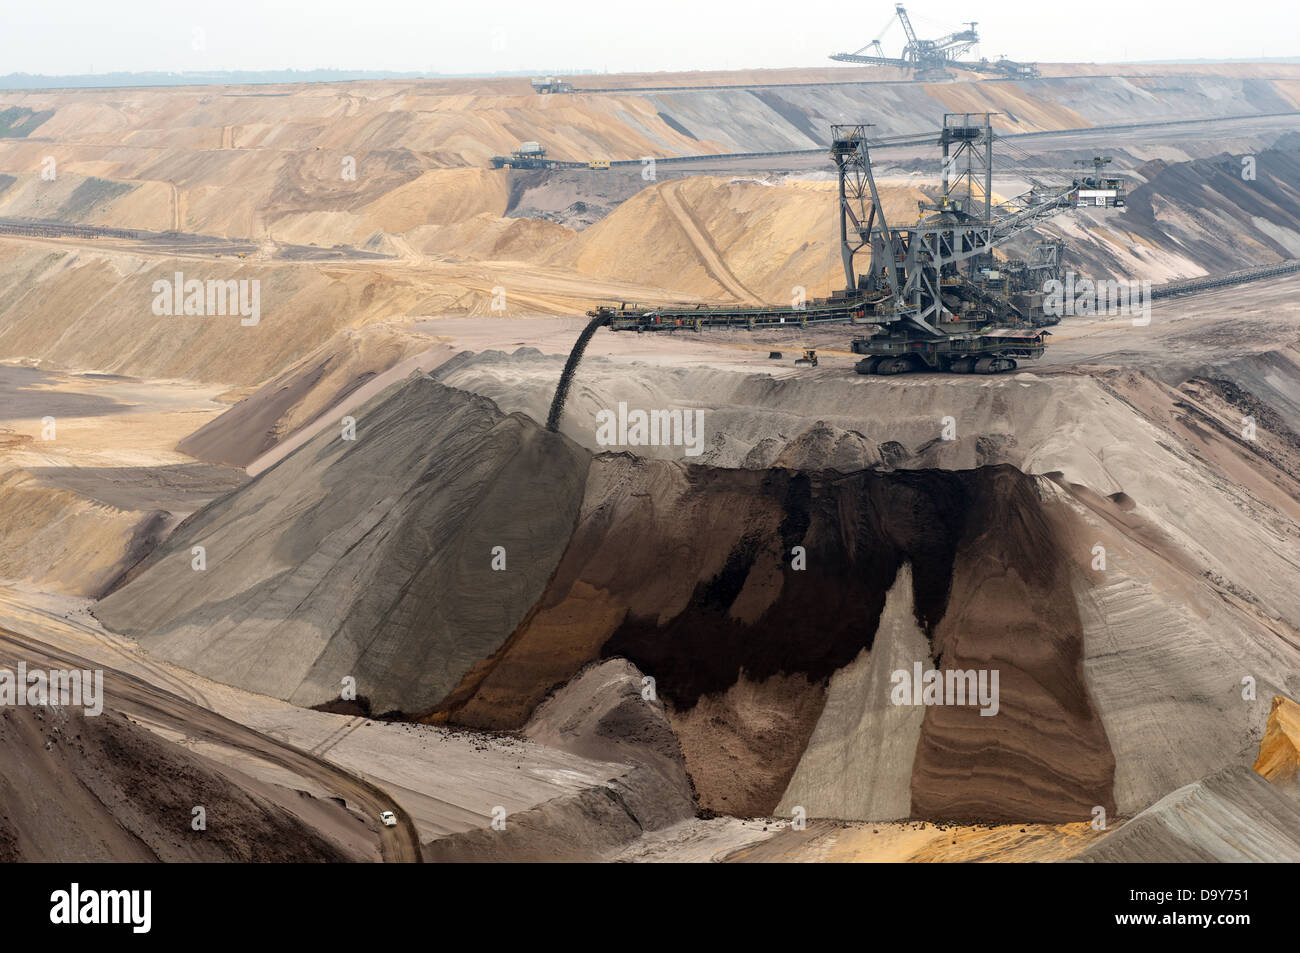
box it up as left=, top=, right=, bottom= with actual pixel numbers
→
left=1075, top=766, right=1300, bottom=863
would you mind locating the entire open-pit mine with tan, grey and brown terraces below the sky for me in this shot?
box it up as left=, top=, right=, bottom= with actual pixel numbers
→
left=0, top=27, right=1300, bottom=884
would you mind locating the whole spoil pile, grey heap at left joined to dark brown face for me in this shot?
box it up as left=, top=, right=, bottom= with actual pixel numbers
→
left=96, top=373, right=1114, bottom=820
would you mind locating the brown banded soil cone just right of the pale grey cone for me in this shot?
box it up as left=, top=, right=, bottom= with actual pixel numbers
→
left=911, top=468, right=1115, bottom=823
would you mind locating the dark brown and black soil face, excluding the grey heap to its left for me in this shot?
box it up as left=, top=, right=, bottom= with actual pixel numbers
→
left=430, top=454, right=1114, bottom=822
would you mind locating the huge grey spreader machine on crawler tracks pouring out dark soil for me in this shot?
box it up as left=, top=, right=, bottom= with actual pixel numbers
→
left=588, top=113, right=1125, bottom=374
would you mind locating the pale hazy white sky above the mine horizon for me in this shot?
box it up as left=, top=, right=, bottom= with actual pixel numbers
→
left=0, top=0, right=1300, bottom=74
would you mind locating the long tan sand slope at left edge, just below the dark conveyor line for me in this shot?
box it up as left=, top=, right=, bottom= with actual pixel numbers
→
left=0, top=241, right=467, bottom=385
